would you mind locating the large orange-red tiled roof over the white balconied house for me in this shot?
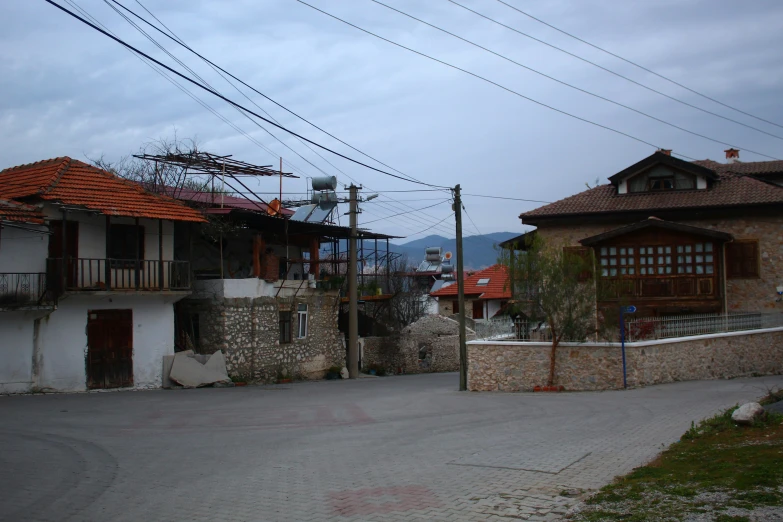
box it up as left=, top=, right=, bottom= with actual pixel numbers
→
left=0, top=157, right=206, bottom=222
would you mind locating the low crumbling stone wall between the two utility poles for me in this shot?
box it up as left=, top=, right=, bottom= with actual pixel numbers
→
left=361, top=315, right=476, bottom=373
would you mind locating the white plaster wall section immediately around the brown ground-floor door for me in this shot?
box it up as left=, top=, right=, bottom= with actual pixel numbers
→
left=39, top=295, right=174, bottom=391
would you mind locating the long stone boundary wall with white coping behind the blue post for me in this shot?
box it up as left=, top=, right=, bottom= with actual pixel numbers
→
left=468, top=328, right=783, bottom=391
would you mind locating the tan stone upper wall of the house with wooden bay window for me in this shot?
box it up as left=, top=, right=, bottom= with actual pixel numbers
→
left=538, top=216, right=783, bottom=312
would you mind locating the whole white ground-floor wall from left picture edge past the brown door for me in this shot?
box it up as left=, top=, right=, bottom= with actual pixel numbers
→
left=0, top=295, right=174, bottom=392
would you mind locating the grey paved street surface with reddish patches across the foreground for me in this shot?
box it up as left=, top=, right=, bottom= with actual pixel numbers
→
left=0, top=374, right=783, bottom=521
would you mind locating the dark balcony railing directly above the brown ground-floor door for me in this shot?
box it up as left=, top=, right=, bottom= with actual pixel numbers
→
left=47, top=258, right=191, bottom=293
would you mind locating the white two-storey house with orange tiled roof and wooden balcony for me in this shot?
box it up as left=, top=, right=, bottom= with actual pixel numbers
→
left=0, top=157, right=205, bottom=393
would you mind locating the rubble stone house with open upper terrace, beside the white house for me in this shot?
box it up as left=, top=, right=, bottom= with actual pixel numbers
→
left=169, top=193, right=396, bottom=382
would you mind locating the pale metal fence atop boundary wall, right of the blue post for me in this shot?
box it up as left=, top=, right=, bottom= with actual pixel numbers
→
left=625, top=313, right=783, bottom=342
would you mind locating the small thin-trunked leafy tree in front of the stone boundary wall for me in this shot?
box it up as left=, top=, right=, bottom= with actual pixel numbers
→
left=500, top=234, right=596, bottom=386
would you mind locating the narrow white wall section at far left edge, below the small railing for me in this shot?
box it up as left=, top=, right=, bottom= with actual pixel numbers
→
left=0, top=312, right=34, bottom=393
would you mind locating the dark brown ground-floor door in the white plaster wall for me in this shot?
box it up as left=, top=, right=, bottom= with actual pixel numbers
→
left=87, top=310, right=133, bottom=389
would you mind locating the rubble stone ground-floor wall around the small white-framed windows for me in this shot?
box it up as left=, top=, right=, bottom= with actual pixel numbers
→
left=181, top=291, right=345, bottom=382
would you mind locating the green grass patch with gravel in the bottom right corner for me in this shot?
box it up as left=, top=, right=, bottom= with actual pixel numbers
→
left=571, top=391, right=783, bottom=522
